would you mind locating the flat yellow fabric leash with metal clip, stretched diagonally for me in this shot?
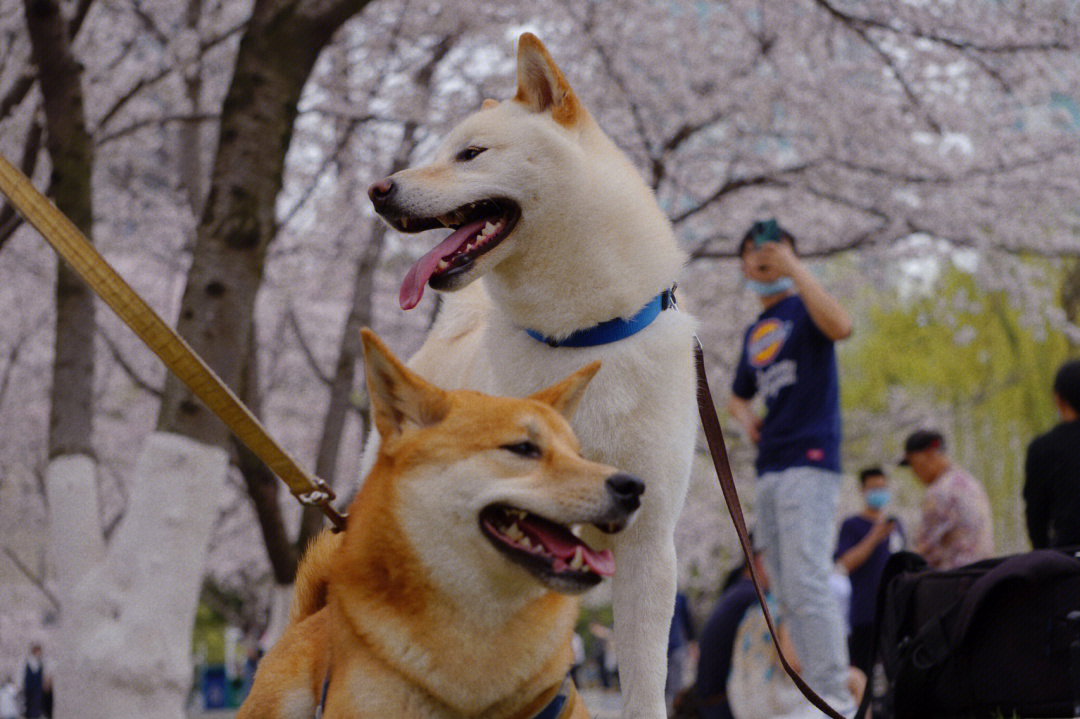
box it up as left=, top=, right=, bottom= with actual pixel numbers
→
left=0, top=155, right=345, bottom=531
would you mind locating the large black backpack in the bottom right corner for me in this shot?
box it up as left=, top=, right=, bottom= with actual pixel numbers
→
left=859, top=548, right=1080, bottom=719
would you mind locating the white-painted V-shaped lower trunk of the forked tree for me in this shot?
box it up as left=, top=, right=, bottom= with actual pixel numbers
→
left=48, top=433, right=228, bottom=719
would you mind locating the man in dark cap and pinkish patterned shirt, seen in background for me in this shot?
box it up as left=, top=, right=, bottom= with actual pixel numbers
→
left=900, top=430, right=994, bottom=569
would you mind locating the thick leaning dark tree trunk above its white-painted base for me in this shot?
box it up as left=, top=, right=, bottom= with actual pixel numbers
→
left=158, top=0, right=368, bottom=447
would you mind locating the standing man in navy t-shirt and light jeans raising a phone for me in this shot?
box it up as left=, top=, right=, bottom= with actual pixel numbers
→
left=728, top=219, right=854, bottom=715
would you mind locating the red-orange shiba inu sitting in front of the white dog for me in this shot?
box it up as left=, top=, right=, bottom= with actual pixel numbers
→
left=238, top=330, right=644, bottom=719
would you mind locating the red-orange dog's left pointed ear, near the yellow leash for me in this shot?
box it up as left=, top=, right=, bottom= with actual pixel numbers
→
left=360, top=327, right=450, bottom=439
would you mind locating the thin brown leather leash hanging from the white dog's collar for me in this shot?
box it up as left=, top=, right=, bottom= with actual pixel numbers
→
left=693, top=337, right=845, bottom=719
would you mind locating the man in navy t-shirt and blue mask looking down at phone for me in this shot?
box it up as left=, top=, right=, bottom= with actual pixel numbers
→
left=834, top=466, right=904, bottom=677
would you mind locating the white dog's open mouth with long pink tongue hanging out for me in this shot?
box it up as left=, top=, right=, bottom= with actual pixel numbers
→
left=397, top=199, right=522, bottom=310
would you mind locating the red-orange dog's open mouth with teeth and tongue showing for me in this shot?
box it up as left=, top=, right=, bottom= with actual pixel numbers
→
left=480, top=504, right=618, bottom=592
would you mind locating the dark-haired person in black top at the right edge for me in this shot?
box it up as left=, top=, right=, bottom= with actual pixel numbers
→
left=1024, top=360, right=1080, bottom=550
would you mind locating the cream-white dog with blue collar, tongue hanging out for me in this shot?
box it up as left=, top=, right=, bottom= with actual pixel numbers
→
left=367, top=35, right=697, bottom=719
